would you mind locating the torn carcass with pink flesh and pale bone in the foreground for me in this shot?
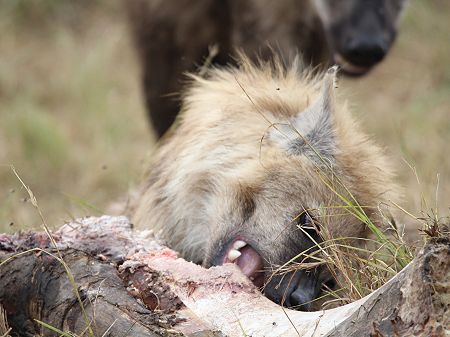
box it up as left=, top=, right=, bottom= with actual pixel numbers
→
left=0, top=216, right=450, bottom=337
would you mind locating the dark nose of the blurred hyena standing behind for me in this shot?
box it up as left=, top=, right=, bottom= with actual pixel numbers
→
left=341, top=36, right=388, bottom=67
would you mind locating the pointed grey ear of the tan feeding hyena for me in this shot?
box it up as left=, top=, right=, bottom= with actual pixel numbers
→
left=270, top=66, right=338, bottom=163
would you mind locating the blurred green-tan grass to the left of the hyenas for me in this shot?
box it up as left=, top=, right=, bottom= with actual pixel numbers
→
left=0, top=1, right=153, bottom=232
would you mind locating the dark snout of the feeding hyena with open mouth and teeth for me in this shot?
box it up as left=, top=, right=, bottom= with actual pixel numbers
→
left=204, top=212, right=335, bottom=311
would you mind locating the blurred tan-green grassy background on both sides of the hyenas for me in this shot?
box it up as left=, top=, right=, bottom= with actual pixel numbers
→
left=0, top=0, right=450, bottom=238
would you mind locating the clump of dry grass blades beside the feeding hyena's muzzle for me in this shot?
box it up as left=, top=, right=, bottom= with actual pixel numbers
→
left=269, top=205, right=412, bottom=308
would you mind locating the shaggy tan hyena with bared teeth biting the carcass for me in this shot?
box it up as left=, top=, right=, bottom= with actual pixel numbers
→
left=132, top=57, right=395, bottom=310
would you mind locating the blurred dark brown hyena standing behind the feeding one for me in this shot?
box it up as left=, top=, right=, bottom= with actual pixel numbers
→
left=126, top=0, right=406, bottom=136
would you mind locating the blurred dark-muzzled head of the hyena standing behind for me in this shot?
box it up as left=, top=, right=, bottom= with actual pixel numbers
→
left=313, top=0, right=406, bottom=75
